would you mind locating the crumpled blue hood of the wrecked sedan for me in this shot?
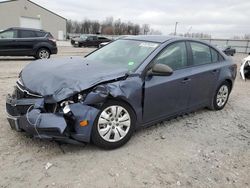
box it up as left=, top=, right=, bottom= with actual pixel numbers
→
left=21, top=57, right=127, bottom=102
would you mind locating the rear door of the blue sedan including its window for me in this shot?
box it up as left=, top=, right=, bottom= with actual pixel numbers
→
left=188, top=42, right=220, bottom=108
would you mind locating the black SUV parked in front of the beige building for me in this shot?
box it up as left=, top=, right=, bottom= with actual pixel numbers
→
left=0, top=28, right=57, bottom=59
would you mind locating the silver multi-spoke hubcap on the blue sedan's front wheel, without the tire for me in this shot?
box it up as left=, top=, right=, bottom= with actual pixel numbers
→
left=97, top=105, right=131, bottom=142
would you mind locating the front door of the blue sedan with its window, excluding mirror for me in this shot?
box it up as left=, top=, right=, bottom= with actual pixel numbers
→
left=143, top=42, right=191, bottom=123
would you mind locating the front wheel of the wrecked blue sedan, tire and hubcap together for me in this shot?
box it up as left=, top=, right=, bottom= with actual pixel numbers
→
left=91, top=100, right=136, bottom=149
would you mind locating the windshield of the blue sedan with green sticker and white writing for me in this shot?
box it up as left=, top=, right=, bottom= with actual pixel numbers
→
left=86, top=40, right=159, bottom=71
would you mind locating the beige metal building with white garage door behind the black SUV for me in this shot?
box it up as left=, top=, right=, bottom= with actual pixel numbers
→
left=0, top=0, right=67, bottom=40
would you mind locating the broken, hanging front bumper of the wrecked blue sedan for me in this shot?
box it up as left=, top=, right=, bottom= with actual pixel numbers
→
left=6, top=95, right=99, bottom=143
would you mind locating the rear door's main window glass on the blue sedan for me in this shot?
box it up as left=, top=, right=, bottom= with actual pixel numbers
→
left=190, top=42, right=212, bottom=65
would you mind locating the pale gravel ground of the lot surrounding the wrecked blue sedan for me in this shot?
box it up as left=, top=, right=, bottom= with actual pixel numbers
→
left=0, top=47, right=250, bottom=188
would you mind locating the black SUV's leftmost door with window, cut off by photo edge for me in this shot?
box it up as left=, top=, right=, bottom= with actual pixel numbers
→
left=0, top=29, right=18, bottom=56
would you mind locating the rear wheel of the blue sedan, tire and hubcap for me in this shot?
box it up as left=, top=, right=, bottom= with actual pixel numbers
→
left=212, top=81, right=231, bottom=110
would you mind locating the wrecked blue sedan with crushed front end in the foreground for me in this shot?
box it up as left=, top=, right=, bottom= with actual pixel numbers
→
left=6, top=36, right=237, bottom=149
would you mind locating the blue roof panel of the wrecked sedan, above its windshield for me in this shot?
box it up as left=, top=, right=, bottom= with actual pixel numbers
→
left=123, top=35, right=178, bottom=43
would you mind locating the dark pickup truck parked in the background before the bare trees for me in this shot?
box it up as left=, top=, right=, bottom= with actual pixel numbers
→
left=71, top=35, right=111, bottom=48
